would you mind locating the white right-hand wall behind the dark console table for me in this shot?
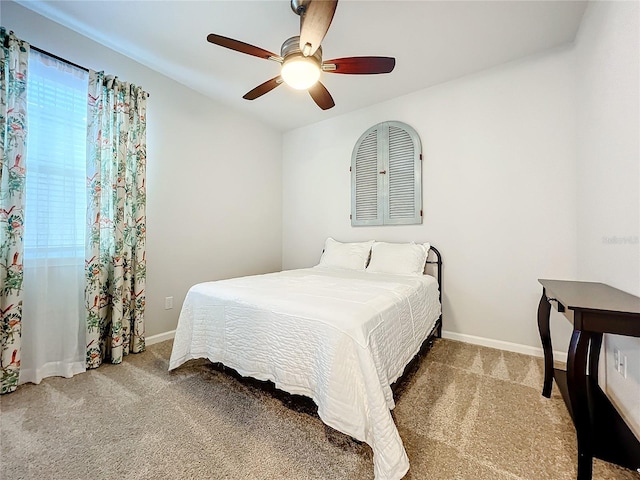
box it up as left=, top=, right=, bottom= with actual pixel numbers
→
left=576, top=2, right=640, bottom=437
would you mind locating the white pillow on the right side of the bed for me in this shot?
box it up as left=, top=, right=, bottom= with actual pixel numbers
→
left=367, top=242, right=431, bottom=275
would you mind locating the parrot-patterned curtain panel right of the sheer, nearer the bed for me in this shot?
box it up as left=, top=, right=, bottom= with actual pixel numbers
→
left=86, top=71, right=147, bottom=368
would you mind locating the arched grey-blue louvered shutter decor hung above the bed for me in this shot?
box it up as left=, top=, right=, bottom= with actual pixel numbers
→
left=351, top=122, right=422, bottom=226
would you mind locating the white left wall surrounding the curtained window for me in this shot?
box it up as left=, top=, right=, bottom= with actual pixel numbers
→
left=0, top=1, right=282, bottom=336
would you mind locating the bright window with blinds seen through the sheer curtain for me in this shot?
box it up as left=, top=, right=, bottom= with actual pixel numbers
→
left=24, top=49, right=88, bottom=258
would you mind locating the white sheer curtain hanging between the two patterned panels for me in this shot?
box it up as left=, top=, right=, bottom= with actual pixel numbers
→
left=19, top=49, right=88, bottom=383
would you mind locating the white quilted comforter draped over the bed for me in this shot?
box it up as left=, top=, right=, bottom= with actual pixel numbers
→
left=169, top=267, right=440, bottom=480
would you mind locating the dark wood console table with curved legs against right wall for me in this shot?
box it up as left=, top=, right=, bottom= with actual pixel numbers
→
left=538, top=280, right=640, bottom=480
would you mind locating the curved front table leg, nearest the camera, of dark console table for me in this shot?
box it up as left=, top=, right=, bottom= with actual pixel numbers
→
left=567, top=330, right=593, bottom=480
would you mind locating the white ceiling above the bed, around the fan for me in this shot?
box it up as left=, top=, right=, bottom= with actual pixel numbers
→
left=18, top=0, right=586, bottom=131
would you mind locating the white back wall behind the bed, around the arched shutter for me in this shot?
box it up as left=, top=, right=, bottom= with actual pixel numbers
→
left=283, top=49, right=577, bottom=351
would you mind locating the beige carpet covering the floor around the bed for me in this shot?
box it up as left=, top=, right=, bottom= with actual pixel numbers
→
left=0, top=340, right=640, bottom=480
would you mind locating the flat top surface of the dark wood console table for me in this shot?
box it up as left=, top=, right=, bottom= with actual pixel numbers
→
left=538, top=279, right=640, bottom=316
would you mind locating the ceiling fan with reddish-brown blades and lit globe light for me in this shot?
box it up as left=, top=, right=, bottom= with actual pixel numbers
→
left=207, top=0, right=396, bottom=110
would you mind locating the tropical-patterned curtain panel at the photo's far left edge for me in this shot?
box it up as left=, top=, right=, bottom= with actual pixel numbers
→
left=0, top=28, right=29, bottom=393
